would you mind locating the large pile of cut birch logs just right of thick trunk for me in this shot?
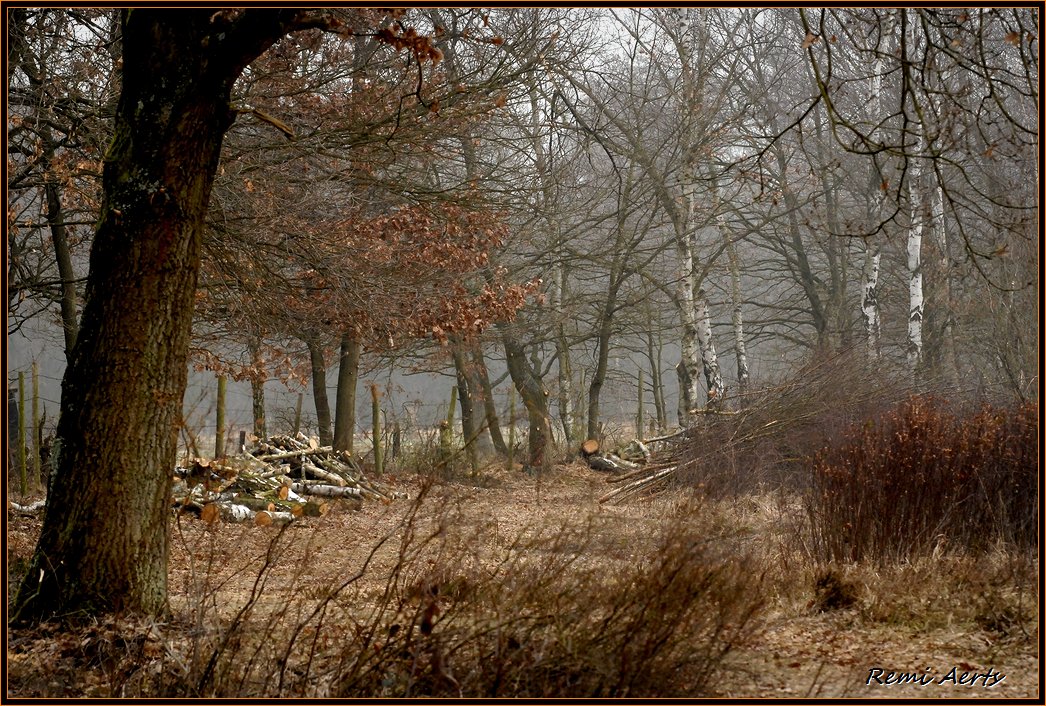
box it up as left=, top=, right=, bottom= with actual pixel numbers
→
left=172, top=434, right=405, bottom=526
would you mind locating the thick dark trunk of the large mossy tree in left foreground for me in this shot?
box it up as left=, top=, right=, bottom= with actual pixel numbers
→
left=14, top=9, right=299, bottom=621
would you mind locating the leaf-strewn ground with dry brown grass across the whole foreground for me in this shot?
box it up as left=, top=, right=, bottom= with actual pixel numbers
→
left=7, top=430, right=1039, bottom=698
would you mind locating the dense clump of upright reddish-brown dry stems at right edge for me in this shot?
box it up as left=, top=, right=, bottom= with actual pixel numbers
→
left=806, top=396, right=1039, bottom=562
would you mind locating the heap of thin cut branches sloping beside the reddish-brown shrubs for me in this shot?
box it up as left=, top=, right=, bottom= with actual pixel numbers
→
left=599, top=349, right=914, bottom=502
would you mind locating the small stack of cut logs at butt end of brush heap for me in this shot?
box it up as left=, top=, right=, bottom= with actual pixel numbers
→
left=581, top=431, right=684, bottom=503
